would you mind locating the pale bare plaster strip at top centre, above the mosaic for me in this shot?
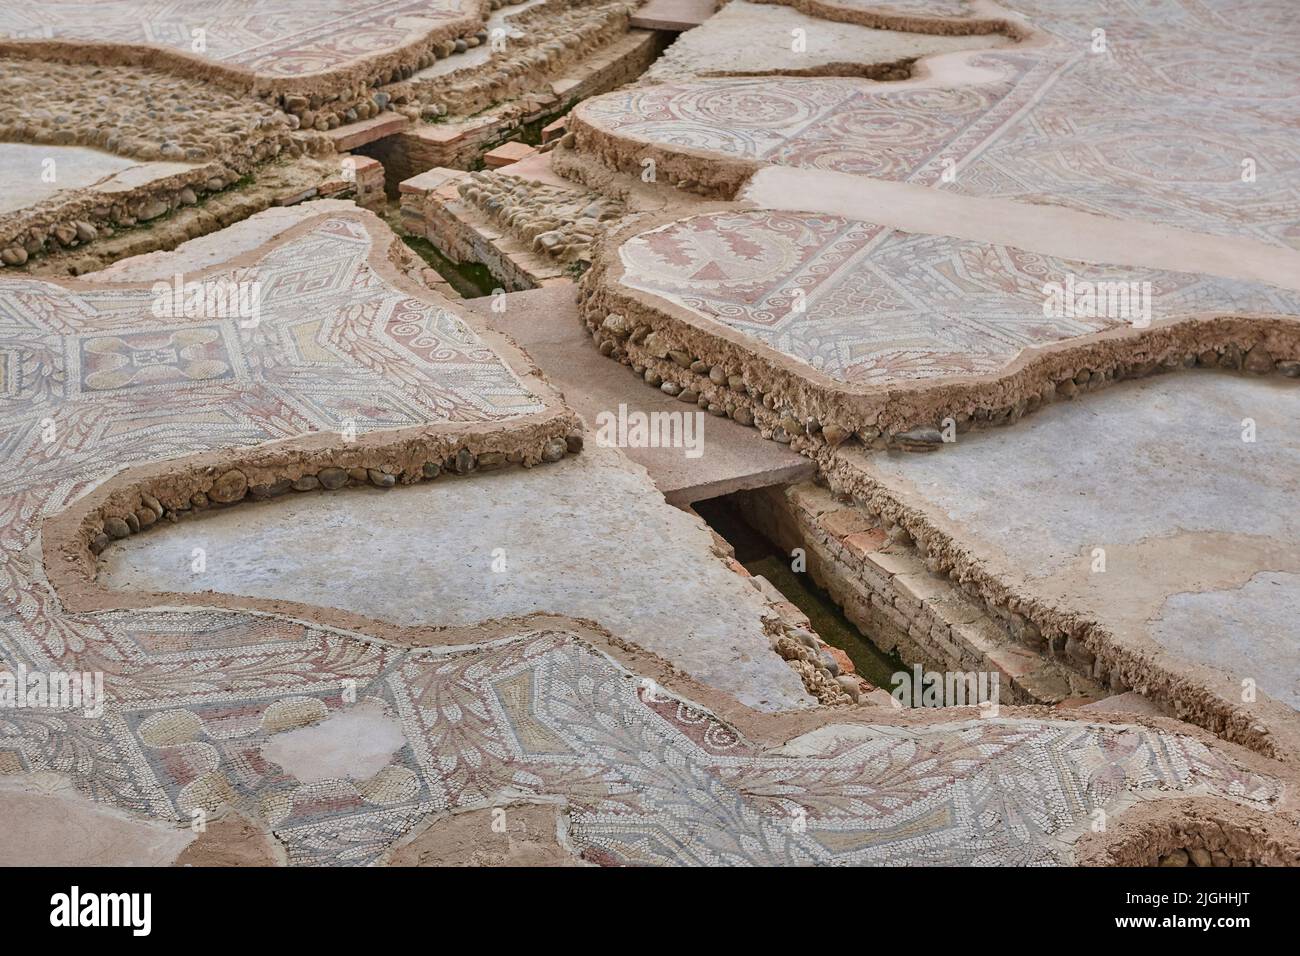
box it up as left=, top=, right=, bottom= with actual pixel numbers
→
left=641, top=0, right=1010, bottom=82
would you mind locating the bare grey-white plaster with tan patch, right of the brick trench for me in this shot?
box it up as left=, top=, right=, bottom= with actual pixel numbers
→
left=867, top=372, right=1300, bottom=708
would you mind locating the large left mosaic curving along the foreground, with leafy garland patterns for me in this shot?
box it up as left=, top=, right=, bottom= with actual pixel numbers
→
left=0, top=216, right=1279, bottom=865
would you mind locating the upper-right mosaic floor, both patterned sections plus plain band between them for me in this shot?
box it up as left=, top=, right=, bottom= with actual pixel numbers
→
left=573, top=3, right=1300, bottom=431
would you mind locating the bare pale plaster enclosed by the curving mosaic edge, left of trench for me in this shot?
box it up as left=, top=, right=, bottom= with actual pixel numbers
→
left=99, top=442, right=811, bottom=710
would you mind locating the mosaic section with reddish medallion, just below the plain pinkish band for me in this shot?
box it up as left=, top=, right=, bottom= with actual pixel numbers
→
left=619, top=211, right=1300, bottom=384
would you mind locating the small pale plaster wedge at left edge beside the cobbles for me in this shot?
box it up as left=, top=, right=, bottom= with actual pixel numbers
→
left=0, top=143, right=194, bottom=213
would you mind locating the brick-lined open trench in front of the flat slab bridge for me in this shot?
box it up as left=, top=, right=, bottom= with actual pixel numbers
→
left=692, top=481, right=1144, bottom=713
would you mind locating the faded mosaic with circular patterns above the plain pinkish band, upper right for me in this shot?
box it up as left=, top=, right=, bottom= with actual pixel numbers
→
left=577, top=0, right=1300, bottom=247
